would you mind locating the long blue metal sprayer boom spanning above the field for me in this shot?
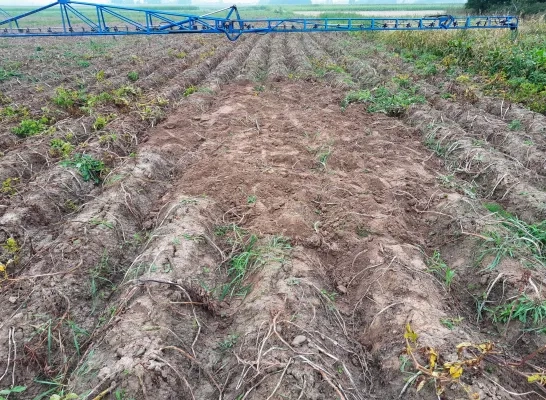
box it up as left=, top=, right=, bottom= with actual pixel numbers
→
left=0, top=0, right=519, bottom=41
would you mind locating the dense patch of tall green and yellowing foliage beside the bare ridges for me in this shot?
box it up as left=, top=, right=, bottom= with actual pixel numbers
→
left=378, top=28, right=546, bottom=113
